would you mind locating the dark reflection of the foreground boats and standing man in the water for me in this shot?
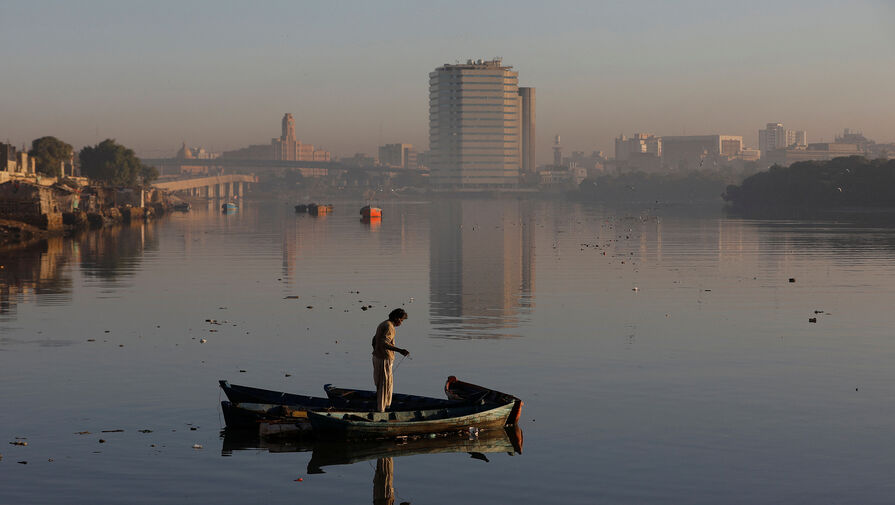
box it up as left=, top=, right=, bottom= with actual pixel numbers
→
left=221, top=426, right=522, bottom=504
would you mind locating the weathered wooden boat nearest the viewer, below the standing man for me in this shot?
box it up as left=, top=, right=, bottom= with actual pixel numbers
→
left=308, top=401, right=515, bottom=438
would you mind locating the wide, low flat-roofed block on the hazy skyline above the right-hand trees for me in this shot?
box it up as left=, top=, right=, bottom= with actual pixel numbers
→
left=662, top=135, right=743, bottom=170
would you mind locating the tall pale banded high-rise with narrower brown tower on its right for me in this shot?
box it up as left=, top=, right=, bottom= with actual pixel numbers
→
left=429, top=58, right=534, bottom=189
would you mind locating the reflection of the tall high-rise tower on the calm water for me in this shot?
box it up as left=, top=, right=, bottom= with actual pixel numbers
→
left=429, top=199, right=535, bottom=338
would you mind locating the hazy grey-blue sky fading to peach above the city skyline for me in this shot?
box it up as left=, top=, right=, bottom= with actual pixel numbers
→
left=0, top=0, right=895, bottom=162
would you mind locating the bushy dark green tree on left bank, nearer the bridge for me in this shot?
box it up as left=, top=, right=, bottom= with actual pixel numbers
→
left=78, top=139, right=158, bottom=186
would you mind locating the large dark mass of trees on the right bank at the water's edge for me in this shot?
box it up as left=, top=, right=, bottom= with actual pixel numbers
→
left=724, top=156, right=895, bottom=210
